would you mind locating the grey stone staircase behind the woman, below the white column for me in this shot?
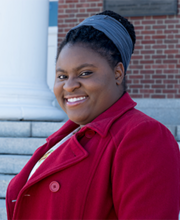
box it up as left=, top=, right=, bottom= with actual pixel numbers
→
left=0, top=121, right=180, bottom=220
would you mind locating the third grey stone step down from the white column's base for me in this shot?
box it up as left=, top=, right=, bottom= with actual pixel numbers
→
left=0, top=155, right=31, bottom=174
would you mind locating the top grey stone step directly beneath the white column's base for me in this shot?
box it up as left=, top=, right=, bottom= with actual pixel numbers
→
left=0, top=121, right=64, bottom=137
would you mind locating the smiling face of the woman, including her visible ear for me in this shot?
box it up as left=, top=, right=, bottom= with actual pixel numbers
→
left=54, top=44, right=124, bottom=125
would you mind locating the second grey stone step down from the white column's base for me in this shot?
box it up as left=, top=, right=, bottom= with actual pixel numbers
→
left=0, top=137, right=46, bottom=155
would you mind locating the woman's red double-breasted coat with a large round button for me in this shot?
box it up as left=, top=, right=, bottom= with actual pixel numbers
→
left=7, top=93, right=180, bottom=220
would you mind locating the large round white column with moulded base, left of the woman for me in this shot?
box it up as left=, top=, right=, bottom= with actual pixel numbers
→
left=0, top=0, right=64, bottom=121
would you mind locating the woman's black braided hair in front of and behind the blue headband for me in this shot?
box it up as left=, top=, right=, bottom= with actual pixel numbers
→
left=56, top=10, right=136, bottom=91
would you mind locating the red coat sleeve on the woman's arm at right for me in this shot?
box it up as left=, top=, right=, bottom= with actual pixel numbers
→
left=112, top=121, right=180, bottom=220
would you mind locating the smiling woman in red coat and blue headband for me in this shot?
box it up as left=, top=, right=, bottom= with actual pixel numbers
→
left=6, top=11, right=180, bottom=220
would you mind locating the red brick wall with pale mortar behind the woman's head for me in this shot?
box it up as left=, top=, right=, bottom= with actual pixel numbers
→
left=58, top=0, right=180, bottom=98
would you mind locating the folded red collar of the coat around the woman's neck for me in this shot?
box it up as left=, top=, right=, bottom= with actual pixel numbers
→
left=47, top=92, right=136, bottom=141
